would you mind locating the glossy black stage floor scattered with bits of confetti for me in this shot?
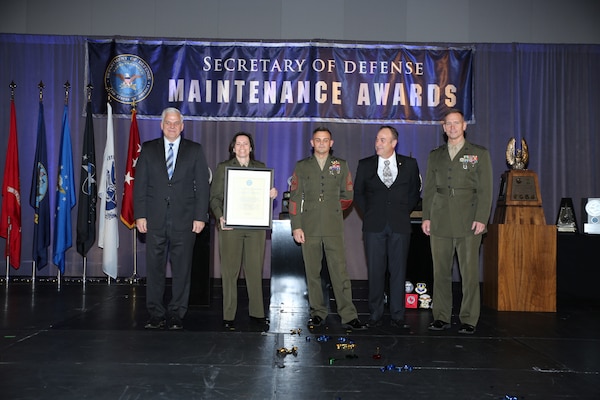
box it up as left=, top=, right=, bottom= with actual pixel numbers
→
left=0, top=282, right=600, bottom=400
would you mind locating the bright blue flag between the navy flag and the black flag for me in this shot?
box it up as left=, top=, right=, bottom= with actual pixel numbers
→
left=53, top=105, right=75, bottom=274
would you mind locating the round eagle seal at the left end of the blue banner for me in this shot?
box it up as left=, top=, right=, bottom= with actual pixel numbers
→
left=104, top=54, right=154, bottom=104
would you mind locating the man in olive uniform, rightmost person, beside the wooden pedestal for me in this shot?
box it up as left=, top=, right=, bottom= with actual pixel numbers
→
left=422, top=110, right=492, bottom=334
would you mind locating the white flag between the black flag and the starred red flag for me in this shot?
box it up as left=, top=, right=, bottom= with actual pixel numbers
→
left=98, top=103, right=119, bottom=279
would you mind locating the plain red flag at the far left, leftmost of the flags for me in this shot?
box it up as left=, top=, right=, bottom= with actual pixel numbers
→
left=0, top=99, right=21, bottom=269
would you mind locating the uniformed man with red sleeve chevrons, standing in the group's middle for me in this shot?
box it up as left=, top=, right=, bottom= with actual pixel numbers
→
left=290, top=128, right=366, bottom=330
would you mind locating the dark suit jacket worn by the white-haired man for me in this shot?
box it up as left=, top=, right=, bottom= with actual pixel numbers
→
left=133, top=136, right=209, bottom=231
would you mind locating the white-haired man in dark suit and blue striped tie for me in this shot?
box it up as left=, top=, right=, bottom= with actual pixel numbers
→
left=133, top=108, right=209, bottom=330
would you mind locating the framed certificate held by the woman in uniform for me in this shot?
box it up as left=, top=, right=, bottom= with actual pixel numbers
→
left=223, top=167, right=273, bottom=229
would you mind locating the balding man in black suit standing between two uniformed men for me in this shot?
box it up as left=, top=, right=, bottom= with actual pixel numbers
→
left=354, top=126, right=421, bottom=329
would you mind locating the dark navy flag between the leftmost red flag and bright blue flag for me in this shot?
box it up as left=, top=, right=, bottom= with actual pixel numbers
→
left=29, top=101, right=50, bottom=270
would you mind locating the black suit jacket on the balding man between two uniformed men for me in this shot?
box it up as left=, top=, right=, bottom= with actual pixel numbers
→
left=354, top=154, right=421, bottom=233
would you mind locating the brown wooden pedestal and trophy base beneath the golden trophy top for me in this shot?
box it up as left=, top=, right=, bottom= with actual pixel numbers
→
left=483, top=170, right=556, bottom=312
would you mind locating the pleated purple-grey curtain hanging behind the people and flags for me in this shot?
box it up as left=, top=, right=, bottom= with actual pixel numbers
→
left=0, top=34, right=600, bottom=279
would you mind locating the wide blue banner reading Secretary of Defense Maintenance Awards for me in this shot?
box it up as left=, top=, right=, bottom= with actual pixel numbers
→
left=86, top=39, right=474, bottom=123
